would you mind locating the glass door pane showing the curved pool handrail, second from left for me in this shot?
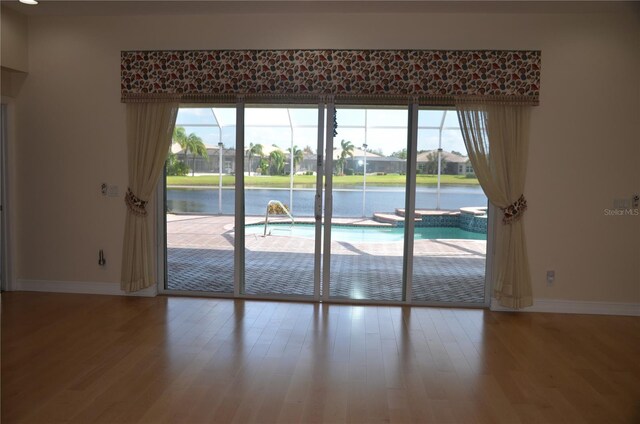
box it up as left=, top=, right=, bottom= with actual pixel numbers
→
left=243, top=106, right=318, bottom=297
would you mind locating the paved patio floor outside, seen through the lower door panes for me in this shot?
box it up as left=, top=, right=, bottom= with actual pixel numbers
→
left=167, top=216, right=486, bottom=303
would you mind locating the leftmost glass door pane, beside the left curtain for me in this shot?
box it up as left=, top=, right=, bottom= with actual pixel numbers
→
left=165, top=106, right=236, bottom=294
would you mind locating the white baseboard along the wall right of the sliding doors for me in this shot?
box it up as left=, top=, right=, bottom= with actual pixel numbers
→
left=491, top=299, right=640, bottom=316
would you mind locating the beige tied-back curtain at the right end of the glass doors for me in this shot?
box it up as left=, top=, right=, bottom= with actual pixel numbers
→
left=456, top=103, right=533, bottom=309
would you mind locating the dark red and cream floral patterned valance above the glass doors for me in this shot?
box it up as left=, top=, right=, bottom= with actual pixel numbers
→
left=121, top=50, right=541, bottom=104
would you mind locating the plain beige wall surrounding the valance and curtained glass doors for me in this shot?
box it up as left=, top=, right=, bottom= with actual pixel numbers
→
left=15, top=9, right=640, bottom=302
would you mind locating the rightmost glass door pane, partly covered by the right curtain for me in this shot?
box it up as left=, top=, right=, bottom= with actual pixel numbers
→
left=412, top=109, right=487, bottom=304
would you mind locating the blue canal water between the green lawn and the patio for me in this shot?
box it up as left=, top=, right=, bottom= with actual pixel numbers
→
left=167, top=186, right=487, bottom=217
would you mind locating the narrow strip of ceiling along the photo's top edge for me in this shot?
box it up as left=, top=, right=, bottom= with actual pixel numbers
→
left=0, top=0, right=640, bottom=16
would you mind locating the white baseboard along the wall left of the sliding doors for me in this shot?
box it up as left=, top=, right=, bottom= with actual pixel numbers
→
left=12, top=280, right=158, bottom=297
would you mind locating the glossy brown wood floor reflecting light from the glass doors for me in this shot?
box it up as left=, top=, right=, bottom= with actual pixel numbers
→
left=2, top=292, right=640, bottom=423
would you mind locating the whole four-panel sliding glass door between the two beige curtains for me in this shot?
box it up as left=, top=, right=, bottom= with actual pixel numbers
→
left=165, top=103, right=488, bottom=305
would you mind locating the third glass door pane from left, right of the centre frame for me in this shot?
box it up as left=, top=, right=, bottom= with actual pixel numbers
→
left=325, top=107, right=408, bottom=301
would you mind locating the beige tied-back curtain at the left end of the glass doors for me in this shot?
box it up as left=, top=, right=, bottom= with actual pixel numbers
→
left=120, top=103, right=178, bottom=292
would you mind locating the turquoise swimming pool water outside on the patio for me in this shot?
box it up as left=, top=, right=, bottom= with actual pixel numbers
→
left=245, top=224, right=486, bottom=243
